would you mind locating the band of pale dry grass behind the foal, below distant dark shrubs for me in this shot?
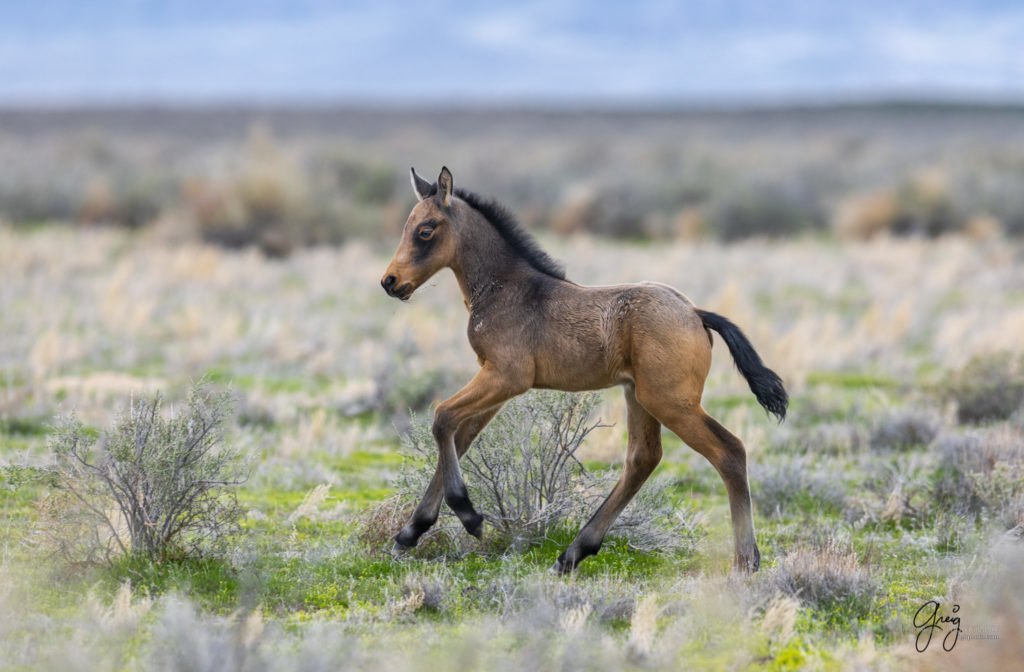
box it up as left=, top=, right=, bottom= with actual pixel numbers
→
left=0, top=227, right=1024, bottom=428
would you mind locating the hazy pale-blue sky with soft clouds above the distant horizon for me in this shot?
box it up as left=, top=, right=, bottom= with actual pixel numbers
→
left=0, top=0, right=1024, bottom=103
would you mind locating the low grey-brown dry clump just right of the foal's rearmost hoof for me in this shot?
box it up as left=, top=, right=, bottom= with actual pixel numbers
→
left=771, top=538, right=878, bottom=613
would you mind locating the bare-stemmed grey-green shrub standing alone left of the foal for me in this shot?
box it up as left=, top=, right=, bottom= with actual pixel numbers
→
left=46, top=385, right=246, bottom=561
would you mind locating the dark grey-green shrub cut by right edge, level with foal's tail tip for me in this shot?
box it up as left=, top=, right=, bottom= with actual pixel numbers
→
left=938, top=352, right=1024, bottom=423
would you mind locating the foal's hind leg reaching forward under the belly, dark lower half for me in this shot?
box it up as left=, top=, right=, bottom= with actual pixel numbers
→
left=551, top=387, right=662, bottom=574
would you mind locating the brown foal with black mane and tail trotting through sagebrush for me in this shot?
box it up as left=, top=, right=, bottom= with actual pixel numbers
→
left=381, top=168, right=788, bottom=573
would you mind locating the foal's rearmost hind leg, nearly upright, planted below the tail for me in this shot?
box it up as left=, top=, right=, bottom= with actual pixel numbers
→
left=641, top=394, right=761, bottom=573
